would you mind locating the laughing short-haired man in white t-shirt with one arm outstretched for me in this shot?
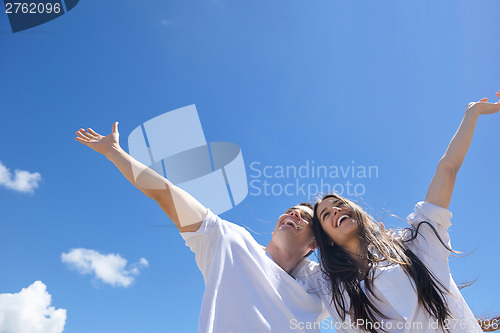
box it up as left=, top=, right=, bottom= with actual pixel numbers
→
left=76, top=123, right=334, bottom=333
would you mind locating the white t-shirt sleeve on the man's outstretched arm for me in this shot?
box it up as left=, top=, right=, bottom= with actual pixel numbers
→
left=180, top=209, right=225, bottom=277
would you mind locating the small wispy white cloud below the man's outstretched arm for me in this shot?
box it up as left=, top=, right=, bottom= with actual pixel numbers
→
left=61, top=248, right=149, bottom=287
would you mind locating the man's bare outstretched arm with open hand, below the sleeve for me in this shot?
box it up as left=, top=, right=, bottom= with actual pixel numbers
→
left=75, top=122, right=207, bottom=232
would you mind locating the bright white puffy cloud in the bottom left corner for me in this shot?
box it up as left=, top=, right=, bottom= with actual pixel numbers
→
left=0, top=281, right=66, bottom=333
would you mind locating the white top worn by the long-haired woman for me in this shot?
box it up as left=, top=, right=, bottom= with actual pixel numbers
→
left=299, top=202, right=483, bottom=333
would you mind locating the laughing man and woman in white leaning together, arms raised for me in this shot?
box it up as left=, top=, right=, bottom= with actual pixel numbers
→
left=76, top=91, right=500, bottom=333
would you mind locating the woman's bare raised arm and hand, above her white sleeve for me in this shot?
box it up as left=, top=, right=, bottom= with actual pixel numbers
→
left=425, top=90, right=500, bottom=208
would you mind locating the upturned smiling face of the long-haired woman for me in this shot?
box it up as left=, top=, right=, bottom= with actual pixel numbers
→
left=316, top=197, right=359, bottom=247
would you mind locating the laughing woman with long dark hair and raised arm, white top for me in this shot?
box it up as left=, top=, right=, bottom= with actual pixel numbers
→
left=309, top=91, right=500, bottom=332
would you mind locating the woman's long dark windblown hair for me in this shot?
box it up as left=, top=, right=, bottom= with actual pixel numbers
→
left=313, top=194, right=455, bottom=333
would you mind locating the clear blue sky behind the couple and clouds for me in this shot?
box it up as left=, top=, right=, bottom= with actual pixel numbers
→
left=0, top=0, right=500, bottom=333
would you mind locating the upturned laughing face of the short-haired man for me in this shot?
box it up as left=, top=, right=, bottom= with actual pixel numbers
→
left=273, top=205, right=316, bottom=255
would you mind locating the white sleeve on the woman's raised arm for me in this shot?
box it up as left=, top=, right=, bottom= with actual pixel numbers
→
left=408, top=201, right=453, bottom=259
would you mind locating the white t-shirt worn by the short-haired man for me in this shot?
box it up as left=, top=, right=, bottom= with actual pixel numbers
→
left=181, top=210, right=327, bottom=333
